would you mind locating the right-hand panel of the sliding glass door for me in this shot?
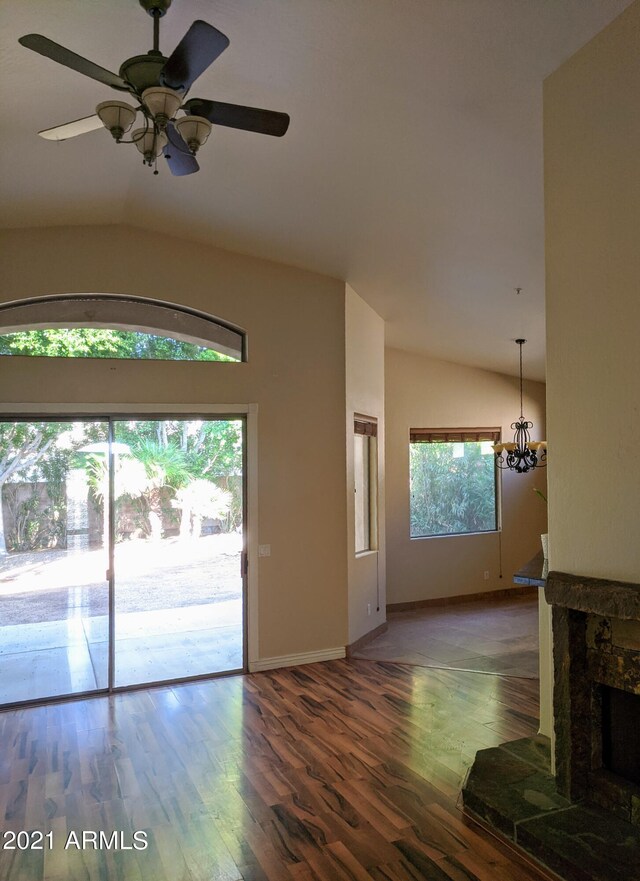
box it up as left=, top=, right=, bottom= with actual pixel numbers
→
left=113, top=419, right=244, bottom=686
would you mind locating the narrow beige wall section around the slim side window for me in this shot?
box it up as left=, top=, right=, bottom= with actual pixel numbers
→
left=345, top=285, right=386, bottom=643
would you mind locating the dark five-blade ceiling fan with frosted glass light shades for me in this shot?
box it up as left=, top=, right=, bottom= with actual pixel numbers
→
left=19, top=0, right=289, bottom=175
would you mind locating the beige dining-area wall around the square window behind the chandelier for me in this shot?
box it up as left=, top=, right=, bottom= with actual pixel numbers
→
left=386, top=343, right=546, bottom=604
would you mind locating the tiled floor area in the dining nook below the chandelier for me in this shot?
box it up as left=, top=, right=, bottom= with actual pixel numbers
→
left=354, top=594, right=538, bottom=679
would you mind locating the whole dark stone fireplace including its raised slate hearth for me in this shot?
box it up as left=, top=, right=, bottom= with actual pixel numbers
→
left=462, top=572, right=640, bottom=881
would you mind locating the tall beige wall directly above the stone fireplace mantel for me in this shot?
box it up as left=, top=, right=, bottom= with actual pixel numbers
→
left=544, top=2, right=640, bottom=582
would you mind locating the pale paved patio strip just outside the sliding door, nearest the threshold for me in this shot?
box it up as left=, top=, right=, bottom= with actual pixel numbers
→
left=0, top=598, right=243, bottom=704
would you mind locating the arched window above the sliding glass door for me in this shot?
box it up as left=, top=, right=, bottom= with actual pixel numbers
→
left=0, top=294, right=246, bottom=361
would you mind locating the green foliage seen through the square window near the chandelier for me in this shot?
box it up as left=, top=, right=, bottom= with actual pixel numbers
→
left=409, top=442, right=497, bottom=538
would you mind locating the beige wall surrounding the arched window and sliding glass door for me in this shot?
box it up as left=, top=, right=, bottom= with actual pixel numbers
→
left=0, top=226, right=347, bottom=659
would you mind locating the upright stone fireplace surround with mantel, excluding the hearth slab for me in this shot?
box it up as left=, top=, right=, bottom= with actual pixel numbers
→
left=545, top=572, right=640, bottom=825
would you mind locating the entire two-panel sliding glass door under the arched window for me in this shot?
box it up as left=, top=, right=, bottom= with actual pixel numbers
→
left=0, top=417, right=245, bottom=705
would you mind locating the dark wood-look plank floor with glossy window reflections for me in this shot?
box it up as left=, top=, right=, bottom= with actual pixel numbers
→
left=0, top=661, right=543, bottom=881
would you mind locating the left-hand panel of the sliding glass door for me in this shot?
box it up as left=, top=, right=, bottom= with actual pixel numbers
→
left=0, top=420, right=109, bottom=704
